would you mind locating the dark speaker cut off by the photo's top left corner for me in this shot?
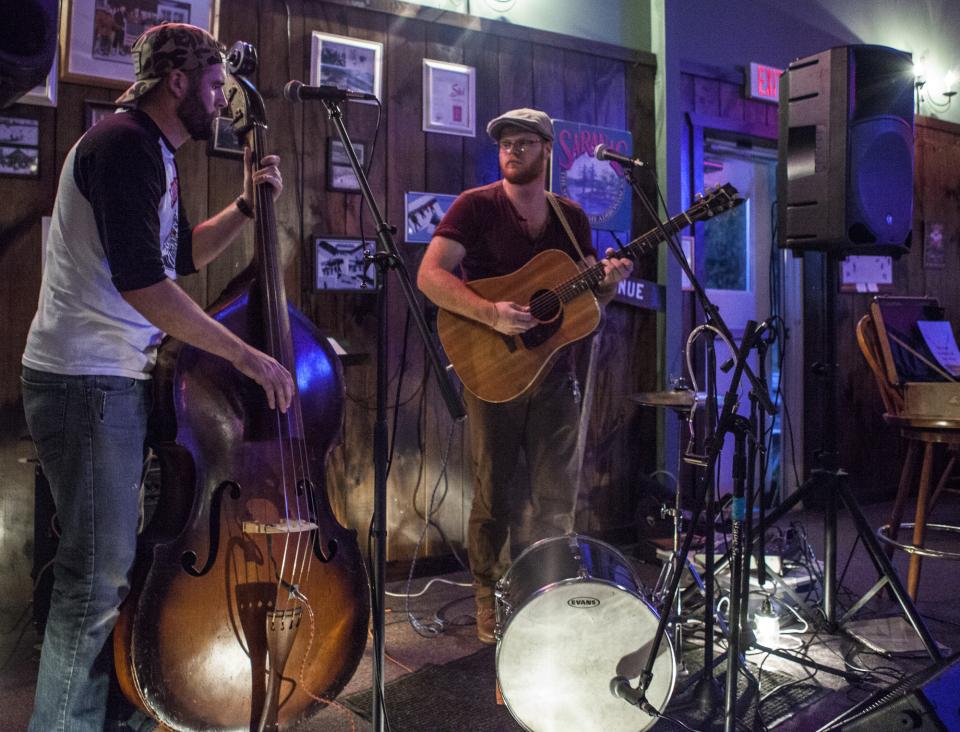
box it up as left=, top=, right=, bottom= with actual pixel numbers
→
left=0, top=0, right=58, bottom=108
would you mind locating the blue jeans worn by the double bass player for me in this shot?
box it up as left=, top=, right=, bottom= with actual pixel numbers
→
left=21, top=368, right=151, bottom=732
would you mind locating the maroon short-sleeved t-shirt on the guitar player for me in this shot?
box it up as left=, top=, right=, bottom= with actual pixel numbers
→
left=434, top=181, right=596, bottom=280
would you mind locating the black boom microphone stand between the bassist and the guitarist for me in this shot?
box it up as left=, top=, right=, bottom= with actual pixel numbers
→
left=321, top=99, right=466, bottom=732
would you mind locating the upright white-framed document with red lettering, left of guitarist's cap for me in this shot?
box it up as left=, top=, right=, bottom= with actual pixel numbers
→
left=423, top=58, right=476, bottom=137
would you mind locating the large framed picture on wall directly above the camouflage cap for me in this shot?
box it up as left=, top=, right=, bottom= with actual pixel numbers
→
left=60, top=0, right=218, bottom=89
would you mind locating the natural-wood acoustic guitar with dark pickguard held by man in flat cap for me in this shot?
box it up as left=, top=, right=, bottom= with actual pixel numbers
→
left=437, top=183, right=743, bottom=402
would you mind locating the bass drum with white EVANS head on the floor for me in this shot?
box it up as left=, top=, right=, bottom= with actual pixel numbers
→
left=496, top=534, right=676, bottom=732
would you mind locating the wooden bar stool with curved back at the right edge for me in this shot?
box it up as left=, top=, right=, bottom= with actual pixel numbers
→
left=857, top=315, right=960, bottom=600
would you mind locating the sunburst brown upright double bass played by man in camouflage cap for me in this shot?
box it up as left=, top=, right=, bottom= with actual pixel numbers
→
left=114, top=44, right=370, bottom=730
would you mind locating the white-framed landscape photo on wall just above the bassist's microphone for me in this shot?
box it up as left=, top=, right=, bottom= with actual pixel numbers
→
left=310, top=31, right=383, bottom=104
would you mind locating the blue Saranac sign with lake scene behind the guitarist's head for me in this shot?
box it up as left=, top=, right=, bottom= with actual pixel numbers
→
left=550, top=119, right=633, bottom=231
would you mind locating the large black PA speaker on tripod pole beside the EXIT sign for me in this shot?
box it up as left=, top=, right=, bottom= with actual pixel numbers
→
left=777, top=45, right=914, bottom=256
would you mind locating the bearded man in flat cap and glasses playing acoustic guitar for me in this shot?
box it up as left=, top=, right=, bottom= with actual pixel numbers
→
left=417, top=109, right=633, bottom=643
